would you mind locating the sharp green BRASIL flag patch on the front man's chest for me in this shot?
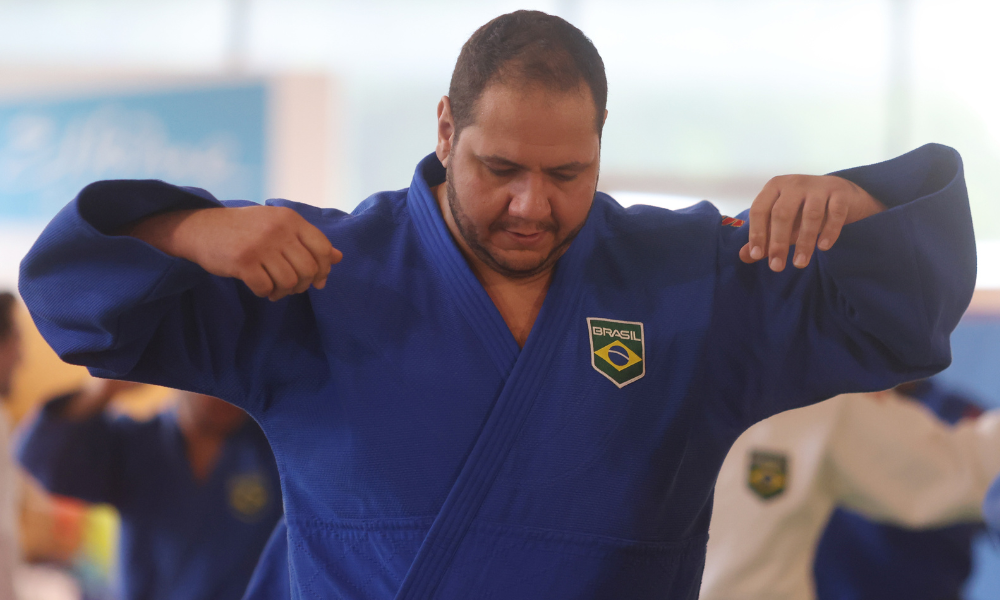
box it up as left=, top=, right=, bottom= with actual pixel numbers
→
left=587, top=317, right=646, bottom=388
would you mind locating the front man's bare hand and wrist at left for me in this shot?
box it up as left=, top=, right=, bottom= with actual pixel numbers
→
left=128, top=206, right=343, bottom=301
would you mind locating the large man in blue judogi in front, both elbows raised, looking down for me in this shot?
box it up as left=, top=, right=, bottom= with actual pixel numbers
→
left=21, top=11, right=975, bottom=599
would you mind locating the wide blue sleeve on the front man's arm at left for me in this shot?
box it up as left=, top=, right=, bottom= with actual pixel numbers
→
left=19, top=181, right=294, bottom=412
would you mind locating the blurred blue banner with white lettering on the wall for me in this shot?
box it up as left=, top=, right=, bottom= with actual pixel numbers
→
left=0, top=83, right=267, bottom=220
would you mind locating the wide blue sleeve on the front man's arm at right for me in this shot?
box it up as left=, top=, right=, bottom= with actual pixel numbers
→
left=705, top=144, right=976, bottom=428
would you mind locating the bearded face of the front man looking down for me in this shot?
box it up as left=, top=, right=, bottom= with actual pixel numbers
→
left=438, top=84, right=601, bottom=278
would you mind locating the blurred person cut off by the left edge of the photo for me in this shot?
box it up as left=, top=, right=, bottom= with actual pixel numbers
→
left=0, top=292, right=21, bottom=600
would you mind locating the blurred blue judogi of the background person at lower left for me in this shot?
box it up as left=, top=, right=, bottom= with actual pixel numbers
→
left=18, top=398, right=281, bottom=600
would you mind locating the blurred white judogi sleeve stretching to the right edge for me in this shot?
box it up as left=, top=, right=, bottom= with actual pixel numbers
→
left=824, top=393, right=1000, bottom=527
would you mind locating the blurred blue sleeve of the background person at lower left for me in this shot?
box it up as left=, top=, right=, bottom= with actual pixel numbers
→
left=16, top=396, right=128, bottom=506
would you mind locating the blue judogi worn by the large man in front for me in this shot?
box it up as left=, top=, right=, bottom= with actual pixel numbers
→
left=21, top=145, right=975, bottom=599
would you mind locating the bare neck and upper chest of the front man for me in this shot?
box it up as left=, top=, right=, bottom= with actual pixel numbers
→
left=433, top=183, right=554, bottom=348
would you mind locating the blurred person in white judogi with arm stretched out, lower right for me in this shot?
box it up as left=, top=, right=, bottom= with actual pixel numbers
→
left=701, top=392, right=1000, bottom=600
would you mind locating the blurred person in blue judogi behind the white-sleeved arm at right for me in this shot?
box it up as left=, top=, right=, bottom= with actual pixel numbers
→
left=814, top=379, right=983, bottom=600
